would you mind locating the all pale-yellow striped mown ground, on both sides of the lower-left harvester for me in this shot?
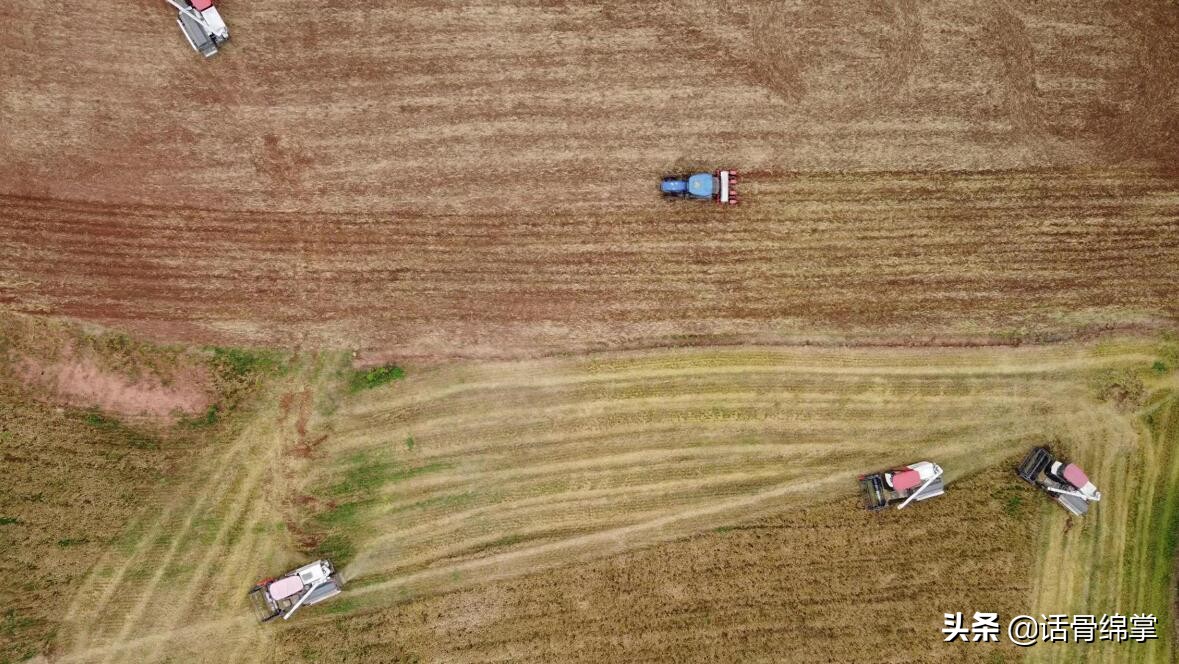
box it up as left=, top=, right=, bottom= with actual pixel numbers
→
left=62, top=343, right=1157, bottom=663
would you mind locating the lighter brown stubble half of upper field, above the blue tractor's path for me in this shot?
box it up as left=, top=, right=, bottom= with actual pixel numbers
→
left=0, top=0, right=1179, bottom=209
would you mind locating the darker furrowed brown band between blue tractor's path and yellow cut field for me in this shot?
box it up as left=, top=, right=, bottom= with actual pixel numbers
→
left=0, top=171, right=1179, bottom=357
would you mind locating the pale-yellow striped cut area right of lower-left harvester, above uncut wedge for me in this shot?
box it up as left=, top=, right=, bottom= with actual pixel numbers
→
left=299, top=347, right=1154, bottom=608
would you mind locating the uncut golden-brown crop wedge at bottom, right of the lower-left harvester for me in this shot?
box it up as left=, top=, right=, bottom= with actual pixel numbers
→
left=278, top=467, right=1039, bottom=664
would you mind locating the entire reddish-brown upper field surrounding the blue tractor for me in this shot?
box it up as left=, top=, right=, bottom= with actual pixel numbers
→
left=0, top=0, right=1179, bottom=357
